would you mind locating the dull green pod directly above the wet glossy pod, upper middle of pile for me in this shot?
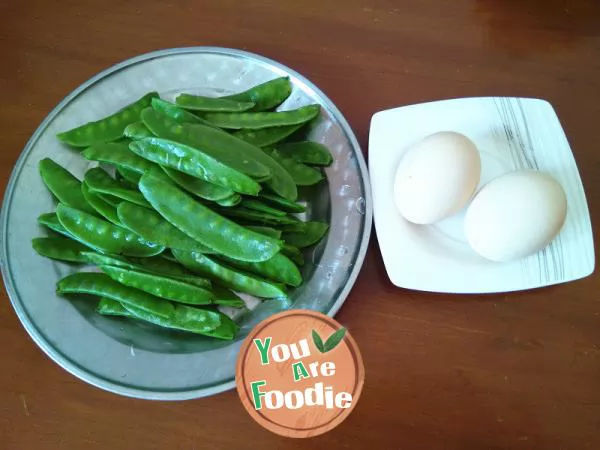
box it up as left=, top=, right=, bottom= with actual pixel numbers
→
left=142, top=108, right=271, bottom=177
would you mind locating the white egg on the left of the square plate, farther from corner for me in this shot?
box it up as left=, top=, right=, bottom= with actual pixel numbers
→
left=394, top=131, right=481, bottom=224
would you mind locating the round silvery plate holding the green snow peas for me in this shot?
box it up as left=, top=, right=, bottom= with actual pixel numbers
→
left=0, top=47, right=372, bottom=400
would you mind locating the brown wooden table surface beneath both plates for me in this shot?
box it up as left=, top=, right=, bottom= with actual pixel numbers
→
left=0, top=0, right=600, bottom=450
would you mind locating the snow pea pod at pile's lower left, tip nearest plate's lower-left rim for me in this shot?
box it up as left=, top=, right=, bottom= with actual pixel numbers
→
left=56, top=272, right=174, bottom=318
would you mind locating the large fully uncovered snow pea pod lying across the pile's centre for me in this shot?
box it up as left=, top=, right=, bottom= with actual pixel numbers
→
left=140, top=171, right=280, bottom=261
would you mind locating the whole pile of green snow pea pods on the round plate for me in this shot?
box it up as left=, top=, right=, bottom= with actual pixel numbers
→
left=32, top=77, right=332, bottom=339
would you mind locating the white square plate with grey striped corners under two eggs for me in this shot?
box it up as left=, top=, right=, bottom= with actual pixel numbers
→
left=369, top=97, right=595, bottom=293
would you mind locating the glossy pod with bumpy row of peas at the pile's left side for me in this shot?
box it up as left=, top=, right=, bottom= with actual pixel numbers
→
left=56, top=204, right=164, bottom=257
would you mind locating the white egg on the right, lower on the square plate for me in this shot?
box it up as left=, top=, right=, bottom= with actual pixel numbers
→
left=465, top=171, right=567, bottom=261
